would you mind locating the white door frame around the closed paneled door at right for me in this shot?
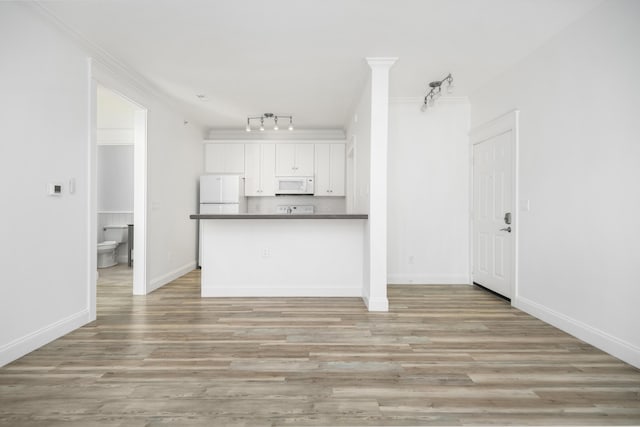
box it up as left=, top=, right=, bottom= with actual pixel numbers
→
left=469, top=110, right=520, bottom=305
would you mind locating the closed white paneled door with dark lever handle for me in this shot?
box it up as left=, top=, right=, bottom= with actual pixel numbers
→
left=472, top=130, right=515, bottom=298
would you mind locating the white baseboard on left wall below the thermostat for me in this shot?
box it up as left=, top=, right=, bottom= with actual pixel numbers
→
left=0, top=309, right=91, bottom=367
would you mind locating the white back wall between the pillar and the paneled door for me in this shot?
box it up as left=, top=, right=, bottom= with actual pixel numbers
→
left=388, top=98, right=469, bottom=284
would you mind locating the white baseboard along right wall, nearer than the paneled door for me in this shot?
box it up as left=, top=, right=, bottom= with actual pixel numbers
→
left=512, top=297, right=640, bottom=368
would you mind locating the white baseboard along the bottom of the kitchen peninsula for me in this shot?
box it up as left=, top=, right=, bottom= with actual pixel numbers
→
left=201, top=285, right=362, bottom=298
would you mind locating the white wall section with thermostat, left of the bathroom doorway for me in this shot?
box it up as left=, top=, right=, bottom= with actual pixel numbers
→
left=0, top=2, right=96, bottom=365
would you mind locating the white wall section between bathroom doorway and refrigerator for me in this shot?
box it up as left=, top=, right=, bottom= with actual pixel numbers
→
left=144, top=104, right=203, bottom=289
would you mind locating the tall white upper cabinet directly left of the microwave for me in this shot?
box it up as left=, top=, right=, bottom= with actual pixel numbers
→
left=244, top=144, right=276, bottom=196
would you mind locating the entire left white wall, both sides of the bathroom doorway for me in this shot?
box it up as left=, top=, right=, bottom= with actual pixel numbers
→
left=0, top=2, right=203, bottom=365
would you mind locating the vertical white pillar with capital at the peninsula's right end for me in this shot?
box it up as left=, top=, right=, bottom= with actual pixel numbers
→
left=363, top=58, right=397, bottom=311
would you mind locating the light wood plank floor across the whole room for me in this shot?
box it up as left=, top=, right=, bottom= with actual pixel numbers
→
left=0, top=267, right=640, bottom=426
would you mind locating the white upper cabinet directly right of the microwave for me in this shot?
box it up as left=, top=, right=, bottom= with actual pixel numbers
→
left=315, top=144, right=345, bottom=196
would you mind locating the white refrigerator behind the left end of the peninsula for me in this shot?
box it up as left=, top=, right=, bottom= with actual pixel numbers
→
left=198, top=175, right=246, bottom=266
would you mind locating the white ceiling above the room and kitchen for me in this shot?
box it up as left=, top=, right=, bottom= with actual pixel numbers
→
left=39, top=0, right=602, bottom=129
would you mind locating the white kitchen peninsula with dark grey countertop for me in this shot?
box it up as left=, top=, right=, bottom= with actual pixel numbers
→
left=190, top=214, right=368, bottom=297
